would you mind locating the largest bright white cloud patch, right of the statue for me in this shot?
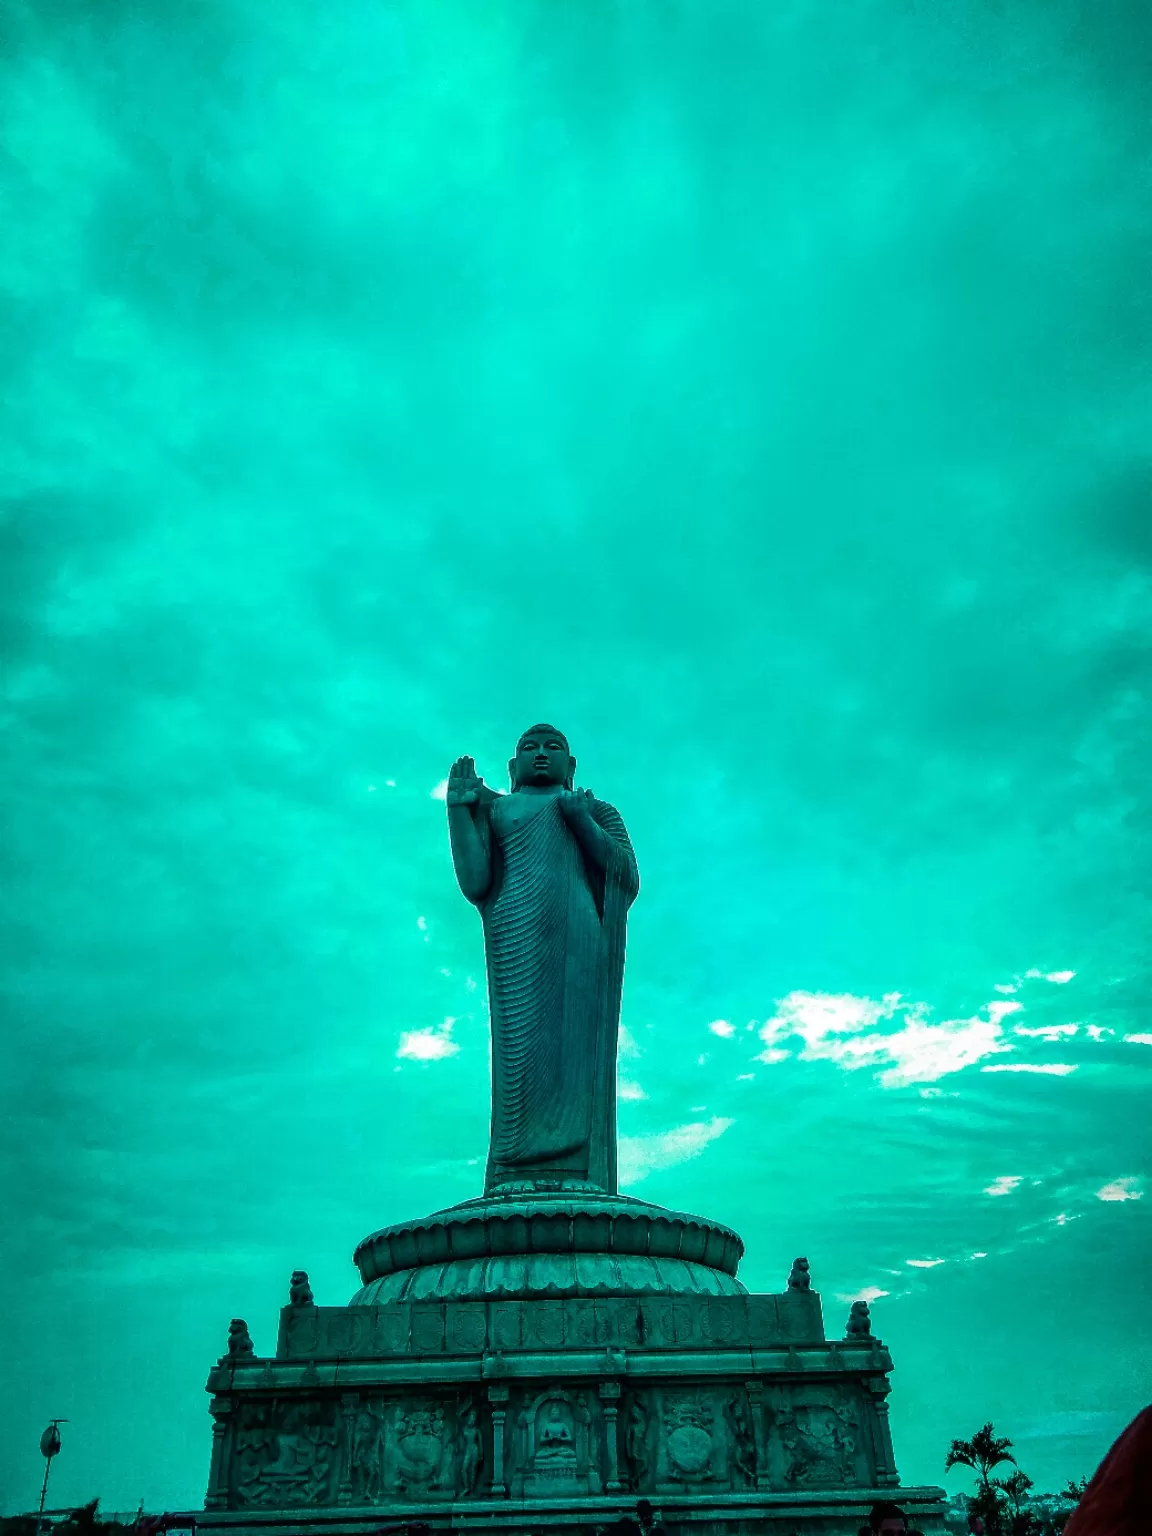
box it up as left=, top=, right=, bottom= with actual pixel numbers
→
left=757, top=992, right=1021, bottom=1087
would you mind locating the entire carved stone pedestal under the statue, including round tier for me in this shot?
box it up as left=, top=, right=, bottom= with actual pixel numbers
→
left=200, top=1192, right=945, bottom=1536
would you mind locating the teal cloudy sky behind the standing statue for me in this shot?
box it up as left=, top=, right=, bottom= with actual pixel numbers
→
left=0, top=0, right=1152, bottom=1510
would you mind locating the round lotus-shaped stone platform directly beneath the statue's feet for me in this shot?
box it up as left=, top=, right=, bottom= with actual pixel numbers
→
left=349, top=1192, right=745, bottom=1307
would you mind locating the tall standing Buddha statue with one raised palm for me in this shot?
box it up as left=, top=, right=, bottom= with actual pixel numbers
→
left=445, top=725, right=639, bottom=1193
